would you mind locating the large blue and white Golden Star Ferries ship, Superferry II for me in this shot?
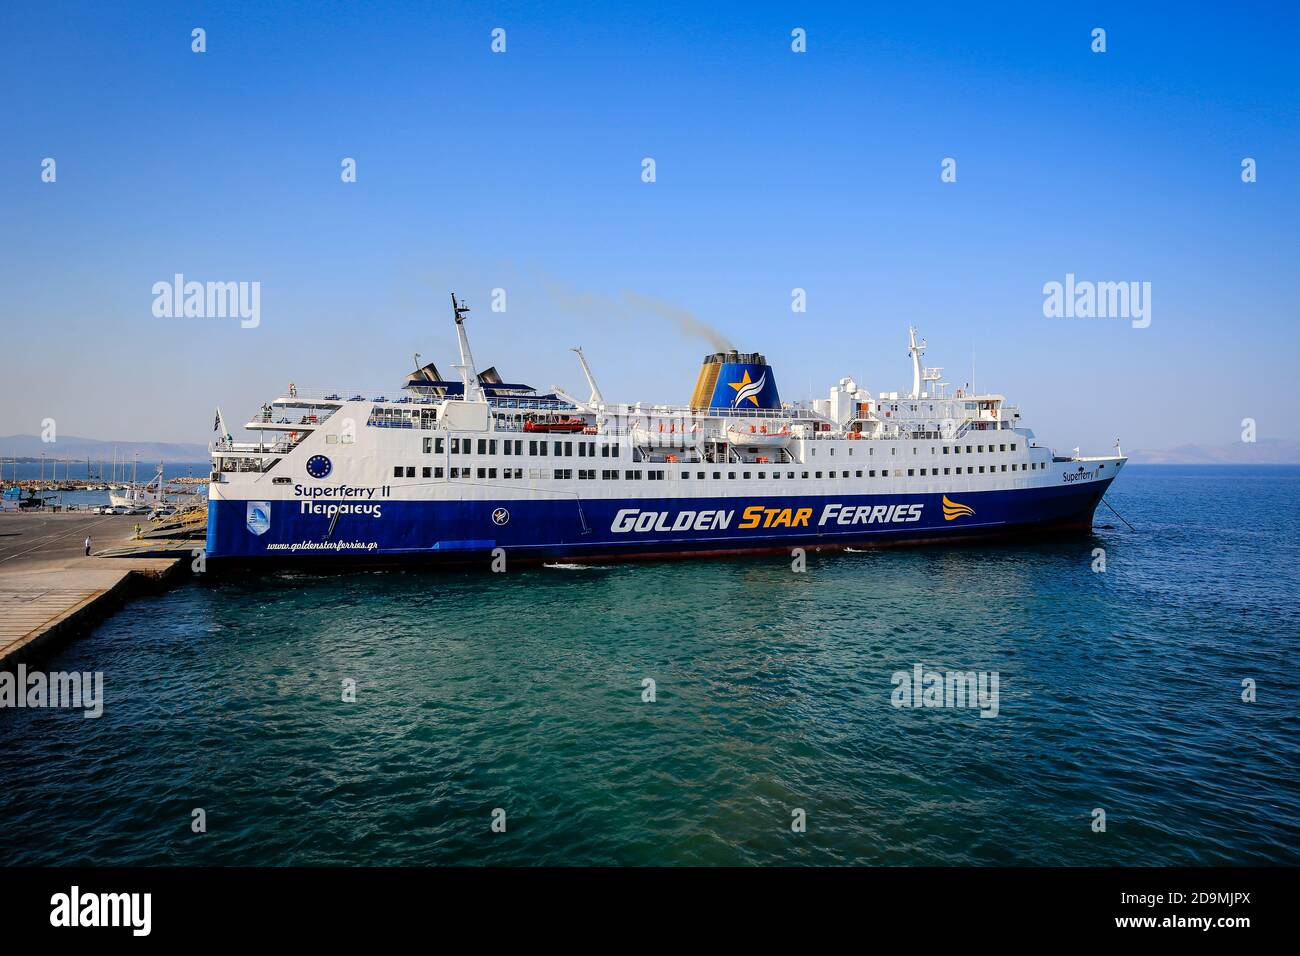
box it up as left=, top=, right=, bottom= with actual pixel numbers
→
left=207, top=294, right=1127, bottom=566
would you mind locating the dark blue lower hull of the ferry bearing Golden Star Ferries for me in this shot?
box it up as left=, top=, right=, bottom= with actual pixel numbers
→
left=207, top=480, right=1110, bottom=563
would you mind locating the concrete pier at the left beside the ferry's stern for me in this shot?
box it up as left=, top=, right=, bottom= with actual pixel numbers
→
left=0, top=514, right=189, bottom=667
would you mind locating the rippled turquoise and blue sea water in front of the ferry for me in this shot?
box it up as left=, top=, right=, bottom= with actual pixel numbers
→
left=0, top=466, right=1300, bottom=865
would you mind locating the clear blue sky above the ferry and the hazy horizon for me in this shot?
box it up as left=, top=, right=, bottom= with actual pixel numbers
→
left=0, top=3, right=1300, bottom=451
